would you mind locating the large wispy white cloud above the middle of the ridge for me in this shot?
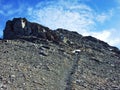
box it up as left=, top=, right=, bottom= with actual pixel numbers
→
left=28, top=1, right=95, bottom=34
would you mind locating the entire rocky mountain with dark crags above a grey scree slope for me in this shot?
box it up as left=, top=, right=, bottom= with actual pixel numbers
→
left=0, top=18, right=120, bottom=90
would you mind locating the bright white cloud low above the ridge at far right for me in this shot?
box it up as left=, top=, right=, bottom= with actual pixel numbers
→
left=89, top=29, right=120, bottom=47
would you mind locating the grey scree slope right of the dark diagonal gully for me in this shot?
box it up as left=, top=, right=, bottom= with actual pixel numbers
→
left=72, top=50, right=120, bottom=90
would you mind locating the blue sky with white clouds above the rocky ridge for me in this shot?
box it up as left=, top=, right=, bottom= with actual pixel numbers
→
left=0, top=0, right=120, bottom=48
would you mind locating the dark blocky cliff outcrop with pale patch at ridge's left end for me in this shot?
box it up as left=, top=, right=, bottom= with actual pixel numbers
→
left=3, top=18, right=59, bottom=41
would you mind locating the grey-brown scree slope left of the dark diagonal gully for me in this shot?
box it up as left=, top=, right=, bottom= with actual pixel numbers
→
left=0, top=39, right=72, bottom=90
